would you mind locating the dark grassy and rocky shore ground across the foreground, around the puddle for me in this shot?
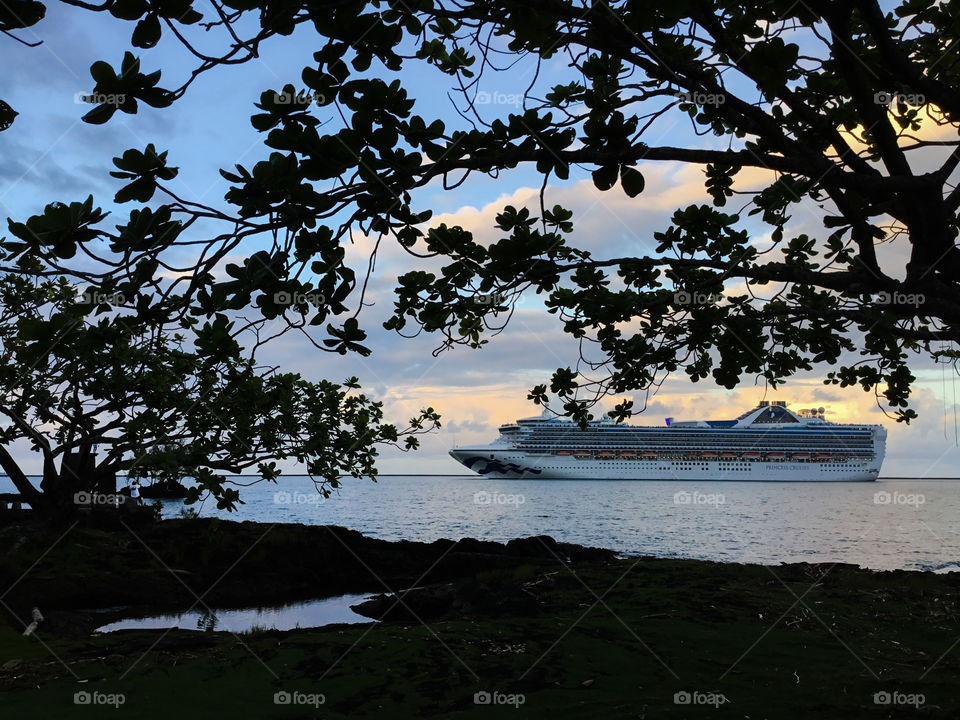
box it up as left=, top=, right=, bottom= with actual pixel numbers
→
left=0, top=513, right=960, bottom=719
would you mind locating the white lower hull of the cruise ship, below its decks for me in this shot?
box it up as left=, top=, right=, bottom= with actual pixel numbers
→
left=450, top=446, right=882, bottom=482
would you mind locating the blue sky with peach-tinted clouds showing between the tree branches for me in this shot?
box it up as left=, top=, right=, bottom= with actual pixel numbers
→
left=0, top=3, right=960, bottom=477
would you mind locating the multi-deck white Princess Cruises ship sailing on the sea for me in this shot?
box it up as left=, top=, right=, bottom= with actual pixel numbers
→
left=450, top=400, right=887, bottom=482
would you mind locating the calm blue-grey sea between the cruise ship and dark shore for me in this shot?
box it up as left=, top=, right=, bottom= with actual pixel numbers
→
left=0, top=475, right=960, bottom=571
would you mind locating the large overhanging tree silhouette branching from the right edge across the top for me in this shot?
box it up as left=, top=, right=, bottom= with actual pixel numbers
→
left=1, top=0, right=960, bottom=420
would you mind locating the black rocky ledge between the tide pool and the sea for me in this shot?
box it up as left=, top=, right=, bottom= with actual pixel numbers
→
left=0, top=516, right=616, bottom=634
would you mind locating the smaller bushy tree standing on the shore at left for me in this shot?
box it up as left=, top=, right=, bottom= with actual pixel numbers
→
left=0, top=228, right=437, bottom=516
